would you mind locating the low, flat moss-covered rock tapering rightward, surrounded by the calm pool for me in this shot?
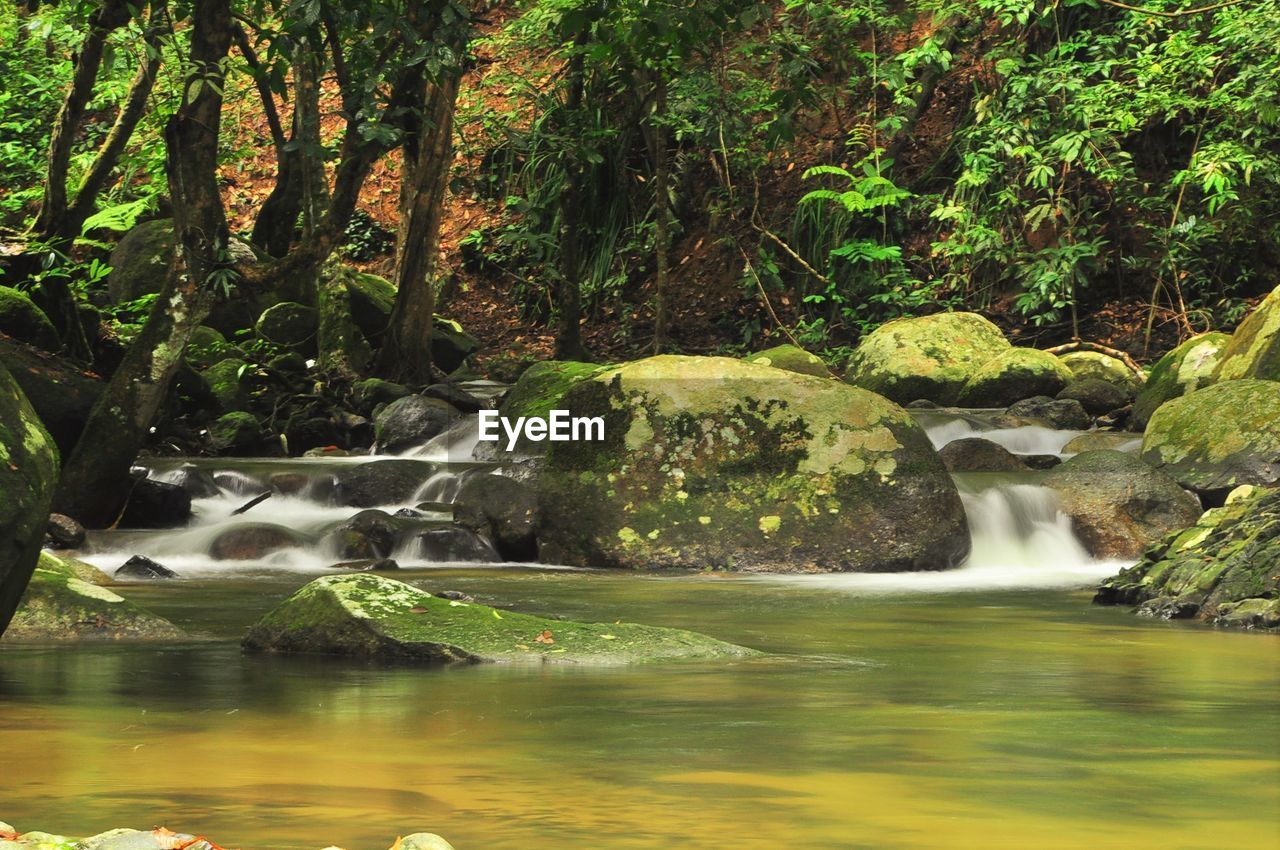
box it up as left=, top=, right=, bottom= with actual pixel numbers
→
left=243, top=573, right=756, bottom=664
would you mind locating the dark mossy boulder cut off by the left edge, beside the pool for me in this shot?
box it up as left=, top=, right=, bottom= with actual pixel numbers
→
left=0, top=364, right=58, bottom=634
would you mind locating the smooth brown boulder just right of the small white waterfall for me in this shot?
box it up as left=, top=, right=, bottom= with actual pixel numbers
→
left=1043, top=449, right=1201, bottom=559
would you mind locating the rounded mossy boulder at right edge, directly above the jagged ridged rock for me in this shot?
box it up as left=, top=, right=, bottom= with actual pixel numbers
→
left=1142, top=379, right=1280, bottom=493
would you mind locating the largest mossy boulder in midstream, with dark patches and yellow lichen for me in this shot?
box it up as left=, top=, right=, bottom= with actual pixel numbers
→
left=536, top=356, right=969, bottom=571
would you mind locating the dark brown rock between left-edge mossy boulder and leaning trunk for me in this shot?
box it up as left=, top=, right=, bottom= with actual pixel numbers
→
left=0, top=337, right=102, bottom=456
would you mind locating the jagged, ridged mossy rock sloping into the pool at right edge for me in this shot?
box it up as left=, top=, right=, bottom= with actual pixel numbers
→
left=1093, top=486, right=1280, bottom=631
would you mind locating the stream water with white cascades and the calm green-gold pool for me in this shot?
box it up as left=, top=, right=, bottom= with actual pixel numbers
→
left=0, top=409, right=1280, bottom=850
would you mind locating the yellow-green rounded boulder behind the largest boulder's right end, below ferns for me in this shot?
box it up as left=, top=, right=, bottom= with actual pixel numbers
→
left=845, top=312, right=1013, bottom=405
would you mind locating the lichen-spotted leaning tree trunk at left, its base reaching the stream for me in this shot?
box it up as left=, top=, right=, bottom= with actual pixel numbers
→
left=55, top=0, right=232, bottom=527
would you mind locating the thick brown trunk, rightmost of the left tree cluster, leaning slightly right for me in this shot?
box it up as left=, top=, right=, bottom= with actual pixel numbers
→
left=378, top=73, right=461, bottom=383
